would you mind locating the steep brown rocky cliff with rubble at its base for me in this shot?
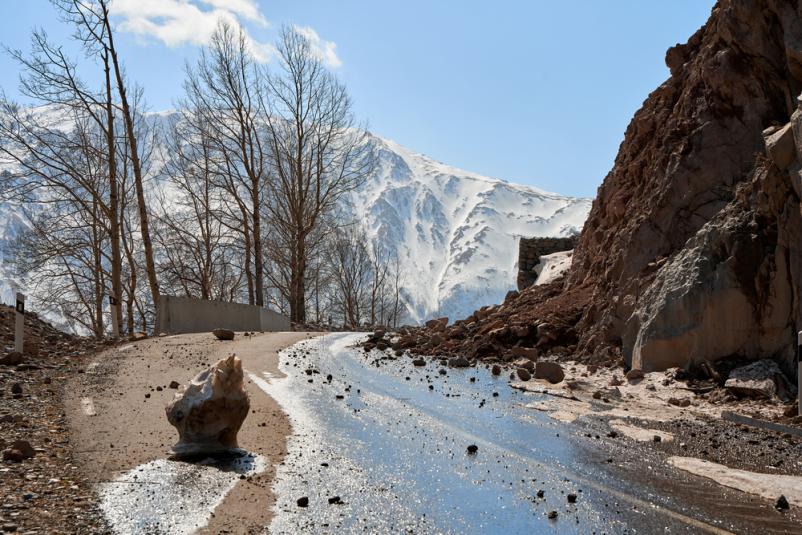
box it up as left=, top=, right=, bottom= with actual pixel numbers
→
left=396, top=0, right=802, bottom=375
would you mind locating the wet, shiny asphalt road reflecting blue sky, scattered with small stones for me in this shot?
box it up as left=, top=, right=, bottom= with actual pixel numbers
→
left=250, top=334, right=801, bottom=534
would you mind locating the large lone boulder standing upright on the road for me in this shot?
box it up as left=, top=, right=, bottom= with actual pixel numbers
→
left=166, top=355, right=250, bottom=456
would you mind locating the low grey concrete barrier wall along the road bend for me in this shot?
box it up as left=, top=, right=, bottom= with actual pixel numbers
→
left=156, top=295, right=290, bottom=334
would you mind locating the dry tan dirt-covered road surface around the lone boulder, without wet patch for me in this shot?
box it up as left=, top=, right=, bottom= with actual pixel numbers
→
left=65, top=332, right=318, bottom=533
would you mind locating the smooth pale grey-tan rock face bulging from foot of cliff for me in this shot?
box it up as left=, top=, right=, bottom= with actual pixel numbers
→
left=622, top=170, right=802, bottom=372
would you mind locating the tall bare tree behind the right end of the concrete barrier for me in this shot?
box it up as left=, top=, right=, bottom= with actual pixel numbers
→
left=266, top=28, right=373, bottom=323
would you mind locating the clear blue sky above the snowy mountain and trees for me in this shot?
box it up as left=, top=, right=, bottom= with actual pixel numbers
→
left=0, top=0, right=714, bottom=197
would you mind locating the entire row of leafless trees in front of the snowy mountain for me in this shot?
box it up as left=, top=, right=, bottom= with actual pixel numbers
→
left=0, top=0, right=403, bottom=336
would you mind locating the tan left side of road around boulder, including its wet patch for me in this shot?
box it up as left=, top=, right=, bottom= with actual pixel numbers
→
left=67, top=332, right=312, bottom=535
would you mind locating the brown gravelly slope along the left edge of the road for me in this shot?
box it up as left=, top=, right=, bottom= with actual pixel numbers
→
left=0, top=305, right=108, bottom=533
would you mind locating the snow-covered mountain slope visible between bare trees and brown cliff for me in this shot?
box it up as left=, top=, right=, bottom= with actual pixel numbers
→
left=352, top=137, right=591, bottom=322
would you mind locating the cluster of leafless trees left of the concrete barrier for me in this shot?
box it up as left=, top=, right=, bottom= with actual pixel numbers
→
left=0, top=0, right=159, bottom=334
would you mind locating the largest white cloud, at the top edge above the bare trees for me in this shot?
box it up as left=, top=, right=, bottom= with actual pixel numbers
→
left=111, top=0, right=275, bottom=62
